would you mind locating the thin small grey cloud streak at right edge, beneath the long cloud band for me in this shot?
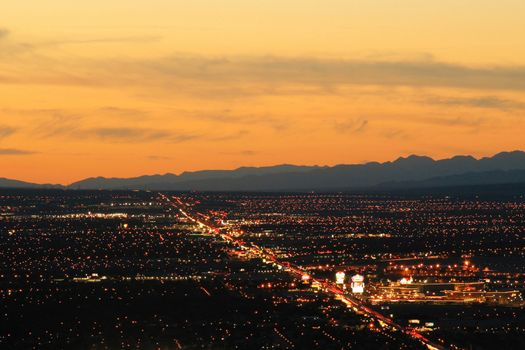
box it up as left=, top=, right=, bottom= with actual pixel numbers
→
left=424, top=96, right=525, bottom=110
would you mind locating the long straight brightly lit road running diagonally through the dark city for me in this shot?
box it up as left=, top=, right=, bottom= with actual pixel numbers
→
left=161, top=194, right=447, bottom=350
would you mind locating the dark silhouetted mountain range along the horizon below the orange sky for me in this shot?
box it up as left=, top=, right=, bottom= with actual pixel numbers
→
left=0, top=151, right=525, bottom=191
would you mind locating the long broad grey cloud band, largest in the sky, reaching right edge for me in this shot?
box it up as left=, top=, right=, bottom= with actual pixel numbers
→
left=102, top=56, right=525, bottom=93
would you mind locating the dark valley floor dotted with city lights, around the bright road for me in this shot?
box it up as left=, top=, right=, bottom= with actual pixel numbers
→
left=0, top=190, right=525, bottom=349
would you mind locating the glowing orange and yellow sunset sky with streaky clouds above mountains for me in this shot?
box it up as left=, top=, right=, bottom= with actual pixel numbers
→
left=0, top=0, right=525, bottom=184
